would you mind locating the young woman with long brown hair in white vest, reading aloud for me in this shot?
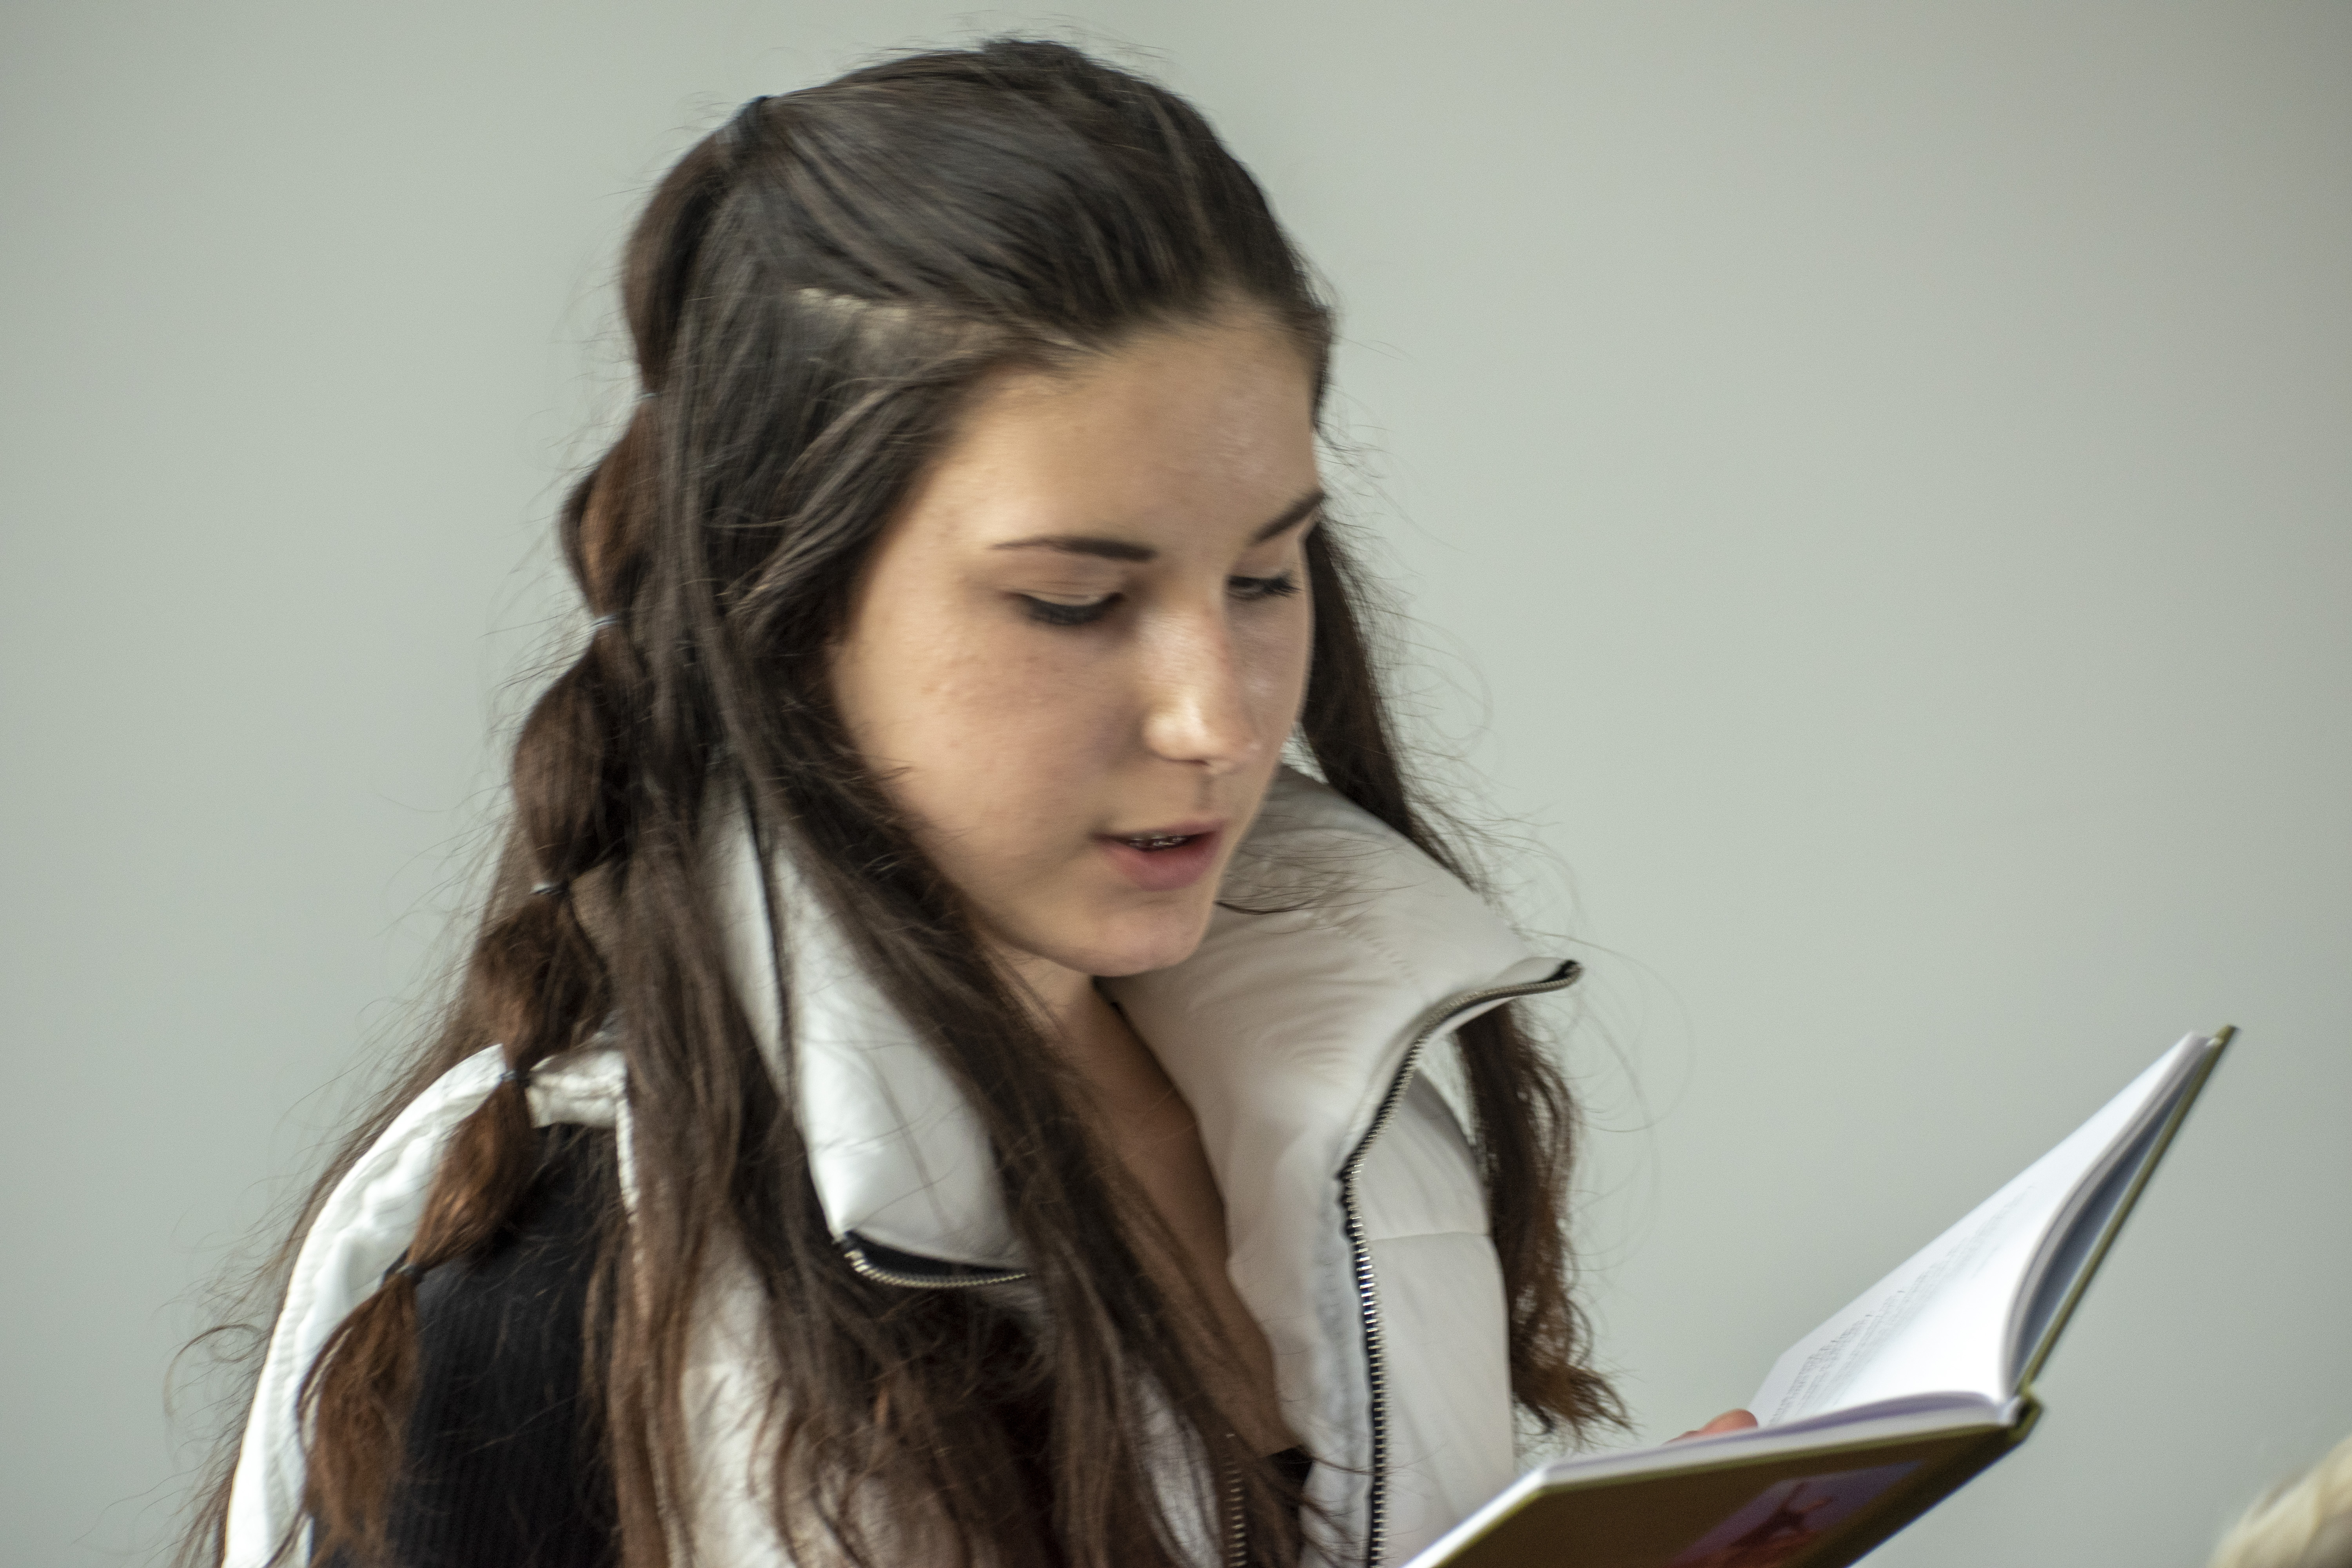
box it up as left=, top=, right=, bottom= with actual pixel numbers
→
left=191, top=42, right=1613, bottom=1568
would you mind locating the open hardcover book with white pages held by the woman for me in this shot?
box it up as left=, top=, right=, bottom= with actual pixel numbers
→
left=1406, top=1027, right=2234, bottom=1568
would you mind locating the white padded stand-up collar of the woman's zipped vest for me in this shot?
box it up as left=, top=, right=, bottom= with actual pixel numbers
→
left=710, top=769, right=1562, bottom=1279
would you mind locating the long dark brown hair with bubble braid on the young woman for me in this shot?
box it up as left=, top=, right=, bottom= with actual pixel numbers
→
left=188, top=40, right=1616, bottom=1568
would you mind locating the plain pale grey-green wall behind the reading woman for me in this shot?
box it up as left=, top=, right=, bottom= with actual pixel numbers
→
left=0, top=0, right=2352, bottom=1568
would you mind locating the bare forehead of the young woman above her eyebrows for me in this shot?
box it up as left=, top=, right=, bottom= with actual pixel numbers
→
left=903, top=318, right=1315, bottom=545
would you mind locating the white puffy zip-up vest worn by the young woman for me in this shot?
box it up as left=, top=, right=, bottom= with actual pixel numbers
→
left=226, top=771, right=1573, bottom=1568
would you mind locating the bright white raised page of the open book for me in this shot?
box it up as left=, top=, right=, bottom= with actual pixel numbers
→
left=1748, top=1037, right=2201, bottom=1425
